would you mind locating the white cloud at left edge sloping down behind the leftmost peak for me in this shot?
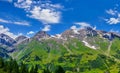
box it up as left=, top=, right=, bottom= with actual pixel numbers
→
left=0, top=25, right=17, bottom=39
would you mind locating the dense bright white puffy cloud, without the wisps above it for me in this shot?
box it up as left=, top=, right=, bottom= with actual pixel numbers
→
left=28, top=6, right=60, bottom=24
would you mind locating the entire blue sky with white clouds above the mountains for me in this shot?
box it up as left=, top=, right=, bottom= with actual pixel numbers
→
left=0, top=0, right=120, bottom=38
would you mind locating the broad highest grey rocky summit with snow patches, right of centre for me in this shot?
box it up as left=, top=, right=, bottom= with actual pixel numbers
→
left=62, top=27, right=98, bottom=40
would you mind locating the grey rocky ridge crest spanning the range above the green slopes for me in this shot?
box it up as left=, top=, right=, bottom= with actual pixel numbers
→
left=0, top=27, right=120, bottom=50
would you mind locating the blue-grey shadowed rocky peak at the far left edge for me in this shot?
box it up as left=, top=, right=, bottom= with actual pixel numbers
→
left=0, top=34, right=16, bottom=47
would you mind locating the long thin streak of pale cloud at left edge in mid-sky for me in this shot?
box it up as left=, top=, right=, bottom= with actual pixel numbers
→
left=0, top=18, right=30, bottom=26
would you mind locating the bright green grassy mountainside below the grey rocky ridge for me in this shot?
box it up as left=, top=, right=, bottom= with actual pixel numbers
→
left=14, top=38, right=120, bottom=73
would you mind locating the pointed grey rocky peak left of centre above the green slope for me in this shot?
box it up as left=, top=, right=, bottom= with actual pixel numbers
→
left=33, top=31, right=50, bottom=40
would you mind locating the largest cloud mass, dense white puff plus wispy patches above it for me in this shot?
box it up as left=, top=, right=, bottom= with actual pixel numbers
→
left=14, top=0, right=63, bottom=24
